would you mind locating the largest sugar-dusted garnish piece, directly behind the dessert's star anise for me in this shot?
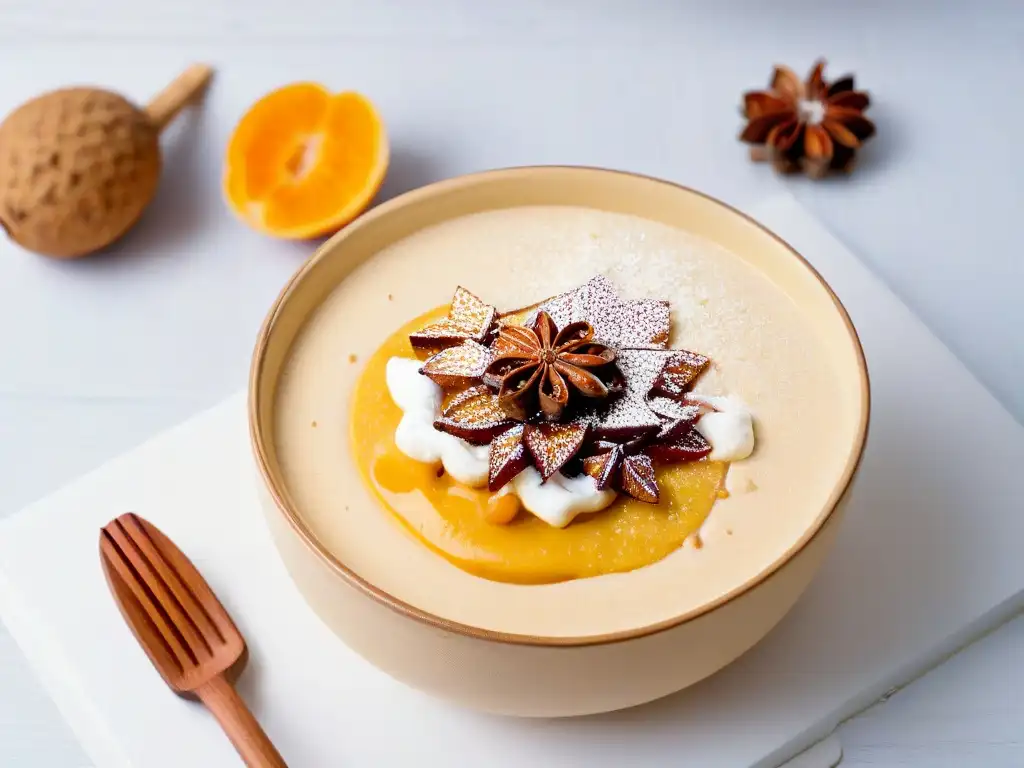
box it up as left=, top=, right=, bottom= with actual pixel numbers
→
left=540, top=274, right=671, bottom=348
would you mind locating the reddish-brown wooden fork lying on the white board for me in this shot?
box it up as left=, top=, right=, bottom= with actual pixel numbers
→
left=99, top=513, right=287, bottom=768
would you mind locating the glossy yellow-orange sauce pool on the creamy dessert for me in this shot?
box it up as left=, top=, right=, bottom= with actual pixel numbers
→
left=351, top=306, right=728, bottom=584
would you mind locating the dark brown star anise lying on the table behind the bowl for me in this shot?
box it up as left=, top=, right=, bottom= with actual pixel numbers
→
left=739, top=59, right=874, bottom=177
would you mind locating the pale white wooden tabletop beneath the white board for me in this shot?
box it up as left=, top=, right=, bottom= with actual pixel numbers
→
left=0, top=0, right=1024, bottom=768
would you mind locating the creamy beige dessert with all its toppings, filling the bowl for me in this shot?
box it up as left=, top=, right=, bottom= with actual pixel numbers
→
left=274, top=207, right=845, bottom=635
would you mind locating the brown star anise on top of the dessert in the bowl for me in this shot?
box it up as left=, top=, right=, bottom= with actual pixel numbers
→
left=483, top=311, right=615, bottom=421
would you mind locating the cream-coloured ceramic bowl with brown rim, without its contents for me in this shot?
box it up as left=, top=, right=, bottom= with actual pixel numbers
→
left=249, top=167, right=868, bottom=717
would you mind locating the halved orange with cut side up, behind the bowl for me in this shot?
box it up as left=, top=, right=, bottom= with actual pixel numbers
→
left=224, top=83, right=388, bottom=239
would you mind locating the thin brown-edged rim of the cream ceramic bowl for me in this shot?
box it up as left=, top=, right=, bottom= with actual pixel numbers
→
left=247, top=165, right=871, bottom=647
